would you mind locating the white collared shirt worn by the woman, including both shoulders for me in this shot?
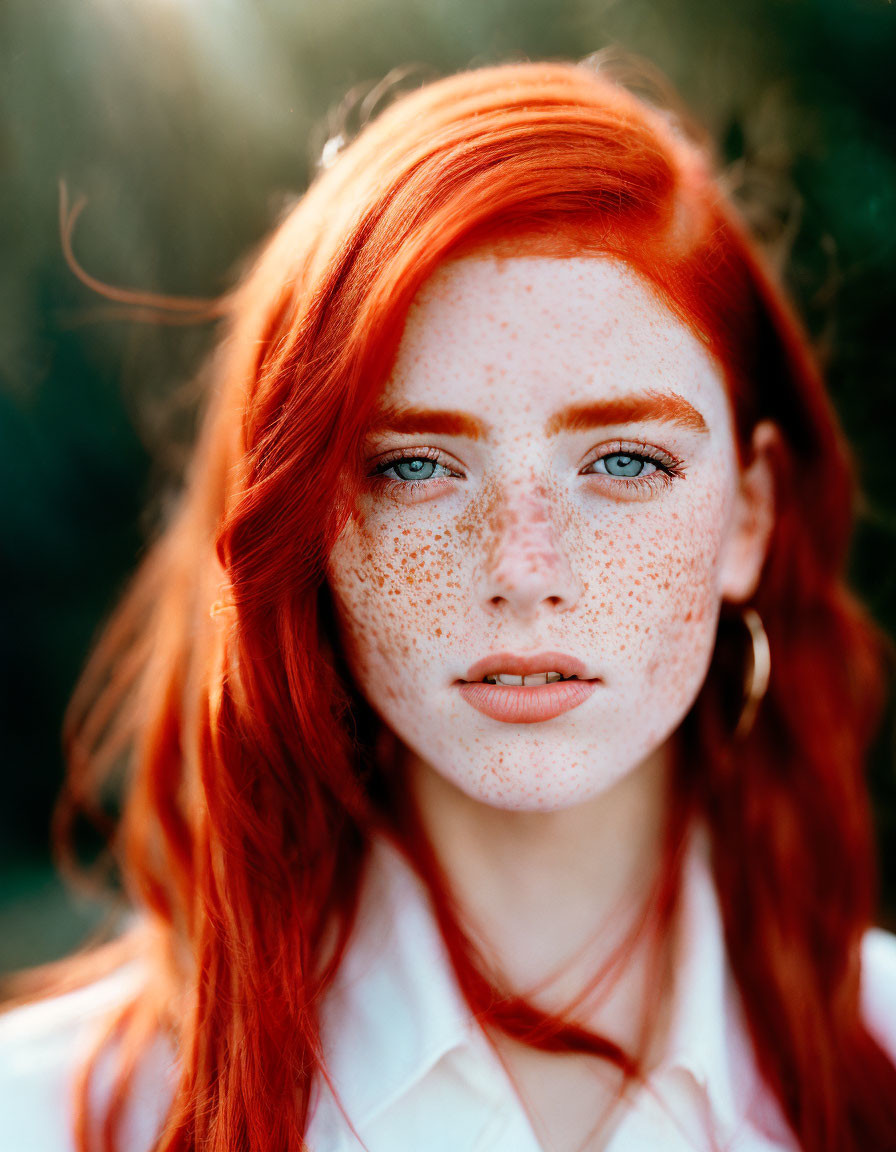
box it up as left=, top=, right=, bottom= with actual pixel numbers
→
left=0, top=836, right=896, bottom=1152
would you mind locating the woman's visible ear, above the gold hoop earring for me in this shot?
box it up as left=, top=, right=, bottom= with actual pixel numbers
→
left=719, top=420, right=781, bottom=604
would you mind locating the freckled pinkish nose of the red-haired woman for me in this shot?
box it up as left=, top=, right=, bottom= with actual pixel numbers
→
left=483, top=486, right=584, bottom=619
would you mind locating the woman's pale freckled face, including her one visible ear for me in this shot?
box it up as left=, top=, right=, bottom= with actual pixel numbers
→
left=327, top=255, right=770, bottom=810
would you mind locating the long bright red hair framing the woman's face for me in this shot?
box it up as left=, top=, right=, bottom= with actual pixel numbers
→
left=12, top=56, right=896, bottom=1152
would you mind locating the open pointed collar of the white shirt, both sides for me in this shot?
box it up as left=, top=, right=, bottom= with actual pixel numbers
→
left=321, top=826, right=749, bottom=1128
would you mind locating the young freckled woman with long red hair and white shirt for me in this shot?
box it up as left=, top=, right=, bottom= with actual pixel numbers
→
left=0, top=63, right=896, bottom=1152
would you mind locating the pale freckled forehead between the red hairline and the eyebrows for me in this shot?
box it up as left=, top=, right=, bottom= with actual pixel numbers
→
left=384, top=255, right=727, bottom=422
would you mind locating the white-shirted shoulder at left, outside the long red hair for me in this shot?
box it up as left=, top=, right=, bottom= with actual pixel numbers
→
left=0, top=967, right=148, bottom=1152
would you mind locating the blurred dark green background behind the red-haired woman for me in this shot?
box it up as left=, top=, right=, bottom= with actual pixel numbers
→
left=0, top=0, right=896, bottom=969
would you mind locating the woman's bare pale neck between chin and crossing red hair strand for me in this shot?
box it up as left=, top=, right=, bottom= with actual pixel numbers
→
left=408, top=748, right=670, bottom=1023
